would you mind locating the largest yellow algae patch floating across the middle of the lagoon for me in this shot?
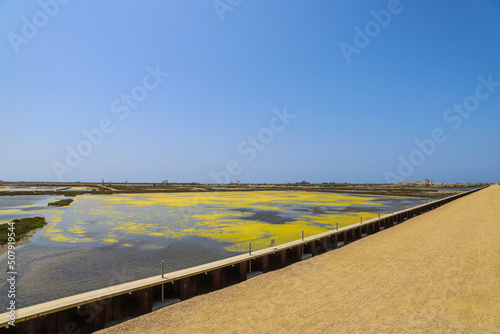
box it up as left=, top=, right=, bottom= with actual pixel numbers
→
left=21, top=191, right=383, bottom=252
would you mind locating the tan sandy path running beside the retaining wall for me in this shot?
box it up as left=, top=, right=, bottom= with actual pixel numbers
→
left=99, top=185, right=500, bottom=333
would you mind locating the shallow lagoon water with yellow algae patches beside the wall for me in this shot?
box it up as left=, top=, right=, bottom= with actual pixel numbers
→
left=0, top=191, right=428, bottom=307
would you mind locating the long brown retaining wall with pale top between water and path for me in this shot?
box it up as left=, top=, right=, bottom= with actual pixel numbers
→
left=0, top=188, right=482, bottom=334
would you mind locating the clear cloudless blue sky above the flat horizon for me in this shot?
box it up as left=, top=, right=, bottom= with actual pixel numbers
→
left=0, top=0, right=500, bottom=182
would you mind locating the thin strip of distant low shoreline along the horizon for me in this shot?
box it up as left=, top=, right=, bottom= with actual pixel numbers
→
left=0, top=181, right=485, bottom=198
